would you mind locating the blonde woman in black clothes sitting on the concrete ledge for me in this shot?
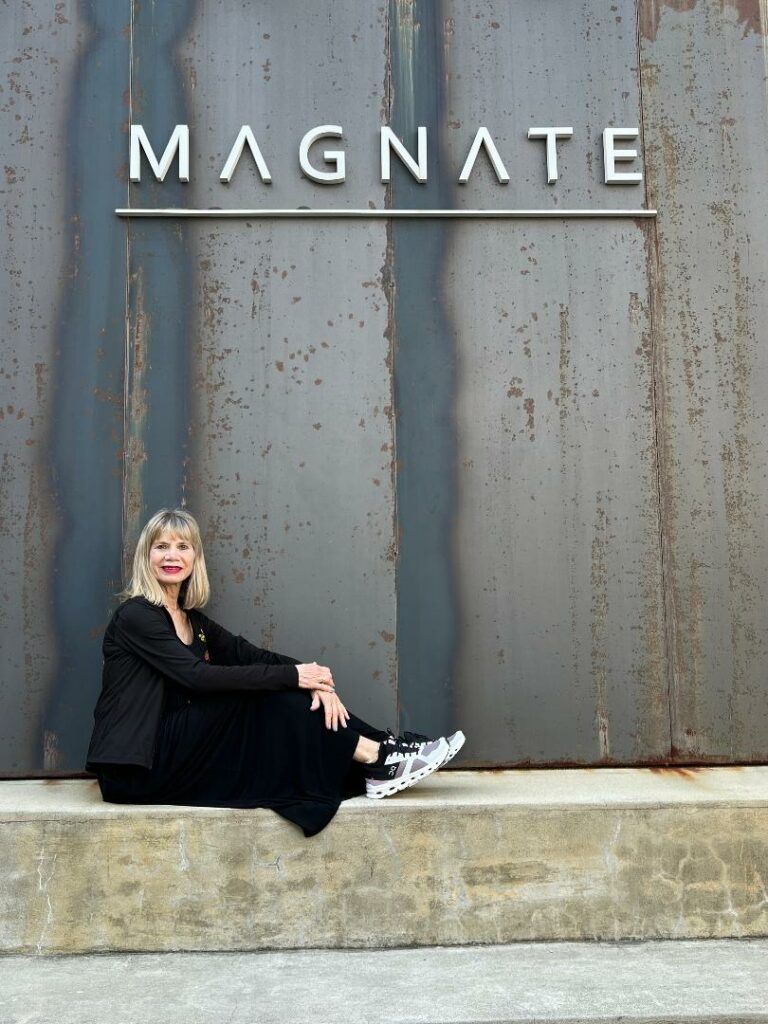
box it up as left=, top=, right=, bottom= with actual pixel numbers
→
left=85, top=509, right=464, bottom=836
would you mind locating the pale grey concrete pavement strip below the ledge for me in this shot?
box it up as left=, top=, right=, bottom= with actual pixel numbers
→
left=0, top=939, right=768, bottom=1024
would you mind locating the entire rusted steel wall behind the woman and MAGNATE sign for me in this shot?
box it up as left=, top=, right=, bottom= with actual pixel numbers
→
left=0, top=0, right=768, bottom=775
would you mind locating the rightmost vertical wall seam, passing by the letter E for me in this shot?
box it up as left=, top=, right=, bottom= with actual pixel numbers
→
left=635, top=0, right=676, bottom=760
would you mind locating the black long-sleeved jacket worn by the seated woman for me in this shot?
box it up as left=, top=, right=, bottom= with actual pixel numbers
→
left=85, top=597, right=299, bottom=771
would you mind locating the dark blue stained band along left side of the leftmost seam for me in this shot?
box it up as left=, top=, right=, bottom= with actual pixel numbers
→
left=42, top=0, right=129, bottom=772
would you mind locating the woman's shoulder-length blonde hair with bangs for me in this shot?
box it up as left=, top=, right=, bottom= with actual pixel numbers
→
left=118, top=509, right=211, bottom=608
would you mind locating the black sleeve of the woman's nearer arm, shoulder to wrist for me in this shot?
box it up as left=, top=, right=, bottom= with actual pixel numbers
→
left=113, top=601, right=299, bottom=690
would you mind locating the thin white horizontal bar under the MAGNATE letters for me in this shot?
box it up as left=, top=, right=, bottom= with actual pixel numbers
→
left=115, top=207, right=656, bottom=220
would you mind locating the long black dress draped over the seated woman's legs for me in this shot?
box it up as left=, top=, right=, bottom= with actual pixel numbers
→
left=97, top=634, right=386, bottom=836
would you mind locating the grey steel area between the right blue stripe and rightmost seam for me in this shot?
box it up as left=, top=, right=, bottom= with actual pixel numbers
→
left=444, top=0, right=669, bottom=764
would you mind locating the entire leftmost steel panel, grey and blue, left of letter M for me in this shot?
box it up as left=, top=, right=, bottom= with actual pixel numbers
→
left=0, top=2, right=128, bottom=774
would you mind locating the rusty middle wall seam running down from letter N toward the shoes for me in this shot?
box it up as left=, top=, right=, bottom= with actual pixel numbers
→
left=383, top=3, right=400, bottom=731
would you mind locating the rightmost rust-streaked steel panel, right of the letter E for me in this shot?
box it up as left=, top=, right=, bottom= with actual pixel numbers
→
left=639, top=0, right=768, bottom=761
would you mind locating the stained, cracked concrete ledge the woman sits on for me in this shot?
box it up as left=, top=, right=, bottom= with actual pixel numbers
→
left=0, top=767, right=768, bottom=953
